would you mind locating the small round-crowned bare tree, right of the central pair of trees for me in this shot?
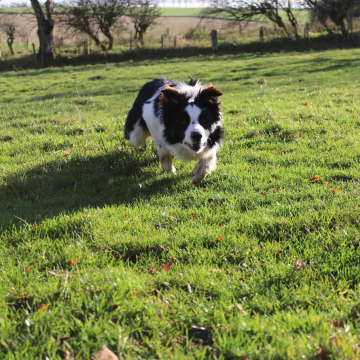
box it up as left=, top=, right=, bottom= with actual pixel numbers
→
left=131, top=0, right=161, bottom=46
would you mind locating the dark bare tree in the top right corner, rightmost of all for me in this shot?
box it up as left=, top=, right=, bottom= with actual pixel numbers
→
left=303, top=0, right=360, bottom=36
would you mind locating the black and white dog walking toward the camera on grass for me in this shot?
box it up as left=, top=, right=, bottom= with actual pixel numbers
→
left=125, top=78, right=223, bottom=183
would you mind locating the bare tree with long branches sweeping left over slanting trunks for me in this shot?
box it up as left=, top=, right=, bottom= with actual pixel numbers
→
left=202, top=0, right=300, bottom=39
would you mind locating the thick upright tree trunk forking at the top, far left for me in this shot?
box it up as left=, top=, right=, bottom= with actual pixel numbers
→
left=30, top=0, right=54, bottom=62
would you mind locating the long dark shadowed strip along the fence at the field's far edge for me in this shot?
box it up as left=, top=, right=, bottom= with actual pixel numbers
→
left=0, top=33, right=360, bottom=76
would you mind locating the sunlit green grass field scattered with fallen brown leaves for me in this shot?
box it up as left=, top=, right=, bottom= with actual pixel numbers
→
left=0, top=50, right=360, bottom=359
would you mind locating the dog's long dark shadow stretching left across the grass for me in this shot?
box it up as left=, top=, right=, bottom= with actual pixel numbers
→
left=0, top=149, right=186, bottom=230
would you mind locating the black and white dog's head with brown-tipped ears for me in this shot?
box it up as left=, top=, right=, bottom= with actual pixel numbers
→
left=159, top=85, right=222, bottom=153
